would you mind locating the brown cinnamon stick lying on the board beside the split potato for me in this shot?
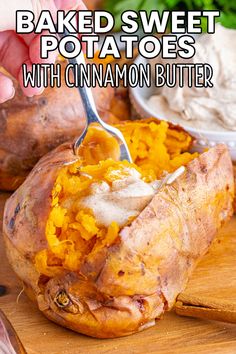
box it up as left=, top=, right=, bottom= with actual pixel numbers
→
left=175, top=294, right=236, bottom=323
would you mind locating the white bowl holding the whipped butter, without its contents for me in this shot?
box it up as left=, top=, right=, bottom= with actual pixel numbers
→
left=130, top=56, right=236, bottom=161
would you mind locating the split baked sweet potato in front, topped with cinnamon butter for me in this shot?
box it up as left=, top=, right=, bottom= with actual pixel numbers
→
left=3, top=123, right=234, bottom=338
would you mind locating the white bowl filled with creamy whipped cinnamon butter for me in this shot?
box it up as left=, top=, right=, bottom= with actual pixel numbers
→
left=130, top=25, right=236, bottom=161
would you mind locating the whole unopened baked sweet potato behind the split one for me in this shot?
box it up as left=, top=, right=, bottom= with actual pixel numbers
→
left=0, top=63, right=121, bottom=191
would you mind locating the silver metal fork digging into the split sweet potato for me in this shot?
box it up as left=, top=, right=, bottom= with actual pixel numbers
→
left=60, top=31, right=132, bottom=162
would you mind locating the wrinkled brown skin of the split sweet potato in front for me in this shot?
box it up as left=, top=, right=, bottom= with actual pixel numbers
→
left=4, top=144, right=234, bottom=338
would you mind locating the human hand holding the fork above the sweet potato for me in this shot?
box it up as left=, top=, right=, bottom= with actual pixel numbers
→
left=0, top=0, right=86, bottom=103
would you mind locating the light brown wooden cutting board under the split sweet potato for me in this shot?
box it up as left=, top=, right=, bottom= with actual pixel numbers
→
left=0, top=194, right=236, bottom=354
